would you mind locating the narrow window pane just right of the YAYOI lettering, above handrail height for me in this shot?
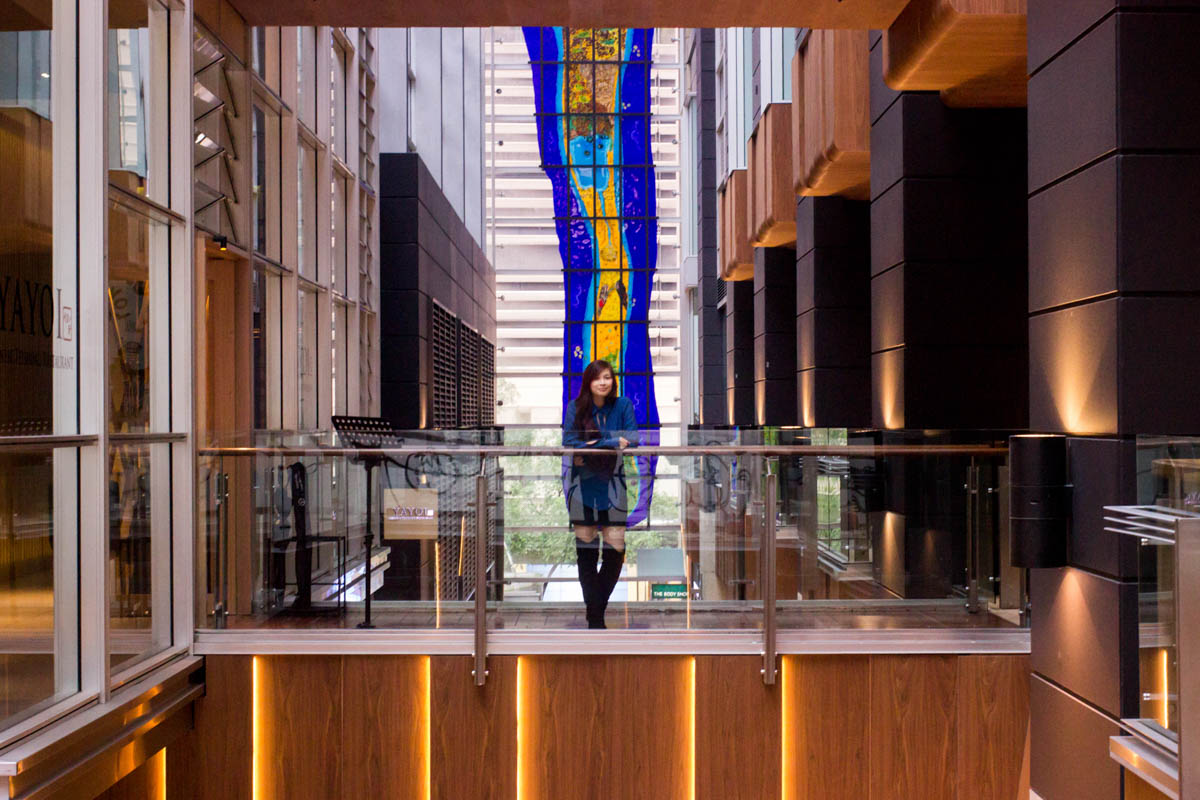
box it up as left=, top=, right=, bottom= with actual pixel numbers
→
left=104, top=195, right=170, bottom=433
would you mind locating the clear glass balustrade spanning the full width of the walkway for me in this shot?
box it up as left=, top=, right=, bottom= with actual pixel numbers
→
left=197, top=427, right=1024, bottom=630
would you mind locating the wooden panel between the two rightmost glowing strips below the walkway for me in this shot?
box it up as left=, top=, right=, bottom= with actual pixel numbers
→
left=695, top=656, right=780, bottom=800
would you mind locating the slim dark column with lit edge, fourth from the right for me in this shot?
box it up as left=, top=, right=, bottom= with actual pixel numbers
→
left=754, top=247, right=797, bottom=425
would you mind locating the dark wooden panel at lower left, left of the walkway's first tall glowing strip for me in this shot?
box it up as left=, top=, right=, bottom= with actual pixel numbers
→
left=167, top=656, right=253, bottom=800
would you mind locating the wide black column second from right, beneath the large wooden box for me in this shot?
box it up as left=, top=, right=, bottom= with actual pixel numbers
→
left=871, top=32, right=1027, bottom=428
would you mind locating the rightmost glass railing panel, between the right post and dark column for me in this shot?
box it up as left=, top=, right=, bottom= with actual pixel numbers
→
left=758, top=428, right=1022, bottom=630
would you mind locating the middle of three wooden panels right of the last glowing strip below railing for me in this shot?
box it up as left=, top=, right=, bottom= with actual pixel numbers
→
left=869, top=655, right=959, bottom=800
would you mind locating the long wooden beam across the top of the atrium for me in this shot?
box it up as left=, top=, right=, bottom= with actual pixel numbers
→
left=236, top=0, right=908, bottom=30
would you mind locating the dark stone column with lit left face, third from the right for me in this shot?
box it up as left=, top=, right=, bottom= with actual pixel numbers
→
left=796, top=197, right=871, bottom=428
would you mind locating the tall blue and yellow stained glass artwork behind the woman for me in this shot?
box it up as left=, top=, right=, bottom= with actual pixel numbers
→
left=524, top=28, right=659, bottom=525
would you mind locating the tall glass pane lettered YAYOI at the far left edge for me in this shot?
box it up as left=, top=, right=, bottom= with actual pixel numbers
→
left=0, top=0, right=78, bottom=435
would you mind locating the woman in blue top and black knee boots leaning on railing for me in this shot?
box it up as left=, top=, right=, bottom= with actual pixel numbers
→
left=563, top=361, right=637, bottom=627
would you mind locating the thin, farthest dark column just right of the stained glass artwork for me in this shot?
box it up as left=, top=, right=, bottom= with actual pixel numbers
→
left=689, top=28, right=728, bottom=425
